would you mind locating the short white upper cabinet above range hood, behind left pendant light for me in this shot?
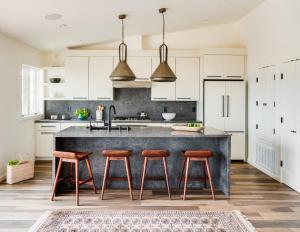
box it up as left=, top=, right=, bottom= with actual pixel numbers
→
left=114, top=56, right=152, bottom=81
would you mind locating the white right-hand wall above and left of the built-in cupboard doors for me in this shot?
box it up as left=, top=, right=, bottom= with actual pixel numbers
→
left=239, top=0, right=300, bottom=163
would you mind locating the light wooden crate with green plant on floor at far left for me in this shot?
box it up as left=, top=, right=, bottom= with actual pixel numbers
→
left=6, top=160, right=34, bottom=184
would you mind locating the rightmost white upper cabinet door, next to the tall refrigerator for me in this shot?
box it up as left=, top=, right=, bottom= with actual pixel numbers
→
left=176, top=57, right=200, bottom=101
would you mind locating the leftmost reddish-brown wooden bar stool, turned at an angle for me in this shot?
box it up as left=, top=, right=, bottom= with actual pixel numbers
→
left=51, top=151, right=97, bottom=205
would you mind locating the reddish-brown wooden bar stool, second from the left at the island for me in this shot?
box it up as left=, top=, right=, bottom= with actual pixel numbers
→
left=101, top=150, right=133, bottom=200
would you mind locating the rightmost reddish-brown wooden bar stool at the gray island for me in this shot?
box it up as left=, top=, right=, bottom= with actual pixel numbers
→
left=178, top=150, right=215, bottom=200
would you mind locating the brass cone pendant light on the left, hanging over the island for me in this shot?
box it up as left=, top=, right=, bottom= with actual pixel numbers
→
left=110, top=15, right=135, bottom=81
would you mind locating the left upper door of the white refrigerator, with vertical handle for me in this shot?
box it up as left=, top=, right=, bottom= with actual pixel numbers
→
left=204, top=81, right=225, bottom=130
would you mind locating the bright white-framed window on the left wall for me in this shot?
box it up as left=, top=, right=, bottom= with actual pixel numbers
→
left=22, top=65, right=43, bottom=117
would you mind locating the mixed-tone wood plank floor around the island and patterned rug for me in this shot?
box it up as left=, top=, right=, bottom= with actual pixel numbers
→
left=0, top=162, right=300, bottom=232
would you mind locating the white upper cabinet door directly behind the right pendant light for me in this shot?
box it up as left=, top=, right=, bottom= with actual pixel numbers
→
left=151, top=57, right=176, bottom=101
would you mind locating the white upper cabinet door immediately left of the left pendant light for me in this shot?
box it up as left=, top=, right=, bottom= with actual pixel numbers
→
left=89, top=57, right=113, bottom=101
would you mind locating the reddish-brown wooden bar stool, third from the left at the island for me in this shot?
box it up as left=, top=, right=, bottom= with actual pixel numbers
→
left=140, top=150, right=171, bottom=200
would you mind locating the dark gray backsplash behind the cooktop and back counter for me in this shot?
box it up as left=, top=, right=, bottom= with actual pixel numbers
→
left=45, top=89, right=196, bottom=120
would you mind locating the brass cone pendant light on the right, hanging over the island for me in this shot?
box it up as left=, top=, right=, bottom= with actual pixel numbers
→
left=150, top=8, right=176, bottom=82
